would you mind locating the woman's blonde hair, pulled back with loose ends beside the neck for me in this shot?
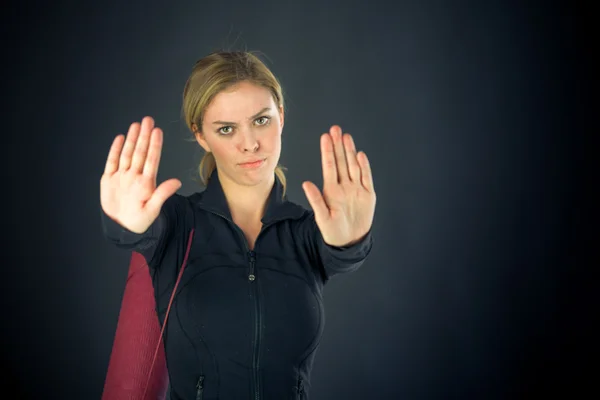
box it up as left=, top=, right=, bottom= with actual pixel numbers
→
left=182, top=51, right=286, bottom=195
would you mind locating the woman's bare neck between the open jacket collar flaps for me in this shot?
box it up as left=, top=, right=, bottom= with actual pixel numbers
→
left=219, top=170, right=275, bottom=223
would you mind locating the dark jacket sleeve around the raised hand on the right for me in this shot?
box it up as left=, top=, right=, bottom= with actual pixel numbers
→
left=307, top=213, right=373, bottom=281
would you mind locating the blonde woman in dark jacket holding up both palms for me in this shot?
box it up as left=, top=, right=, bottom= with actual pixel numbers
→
left=100, top=52, right=376, bottom=400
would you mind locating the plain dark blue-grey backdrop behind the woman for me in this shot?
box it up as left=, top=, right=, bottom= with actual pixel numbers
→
left=1, top=1, right=598, bottom=400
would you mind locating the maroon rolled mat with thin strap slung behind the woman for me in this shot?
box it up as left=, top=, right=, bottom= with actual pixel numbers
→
left=102, top=229, right=194, bottom=400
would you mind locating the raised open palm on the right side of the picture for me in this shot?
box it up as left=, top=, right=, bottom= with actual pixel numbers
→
left=302, top=125, right=376, bottom=247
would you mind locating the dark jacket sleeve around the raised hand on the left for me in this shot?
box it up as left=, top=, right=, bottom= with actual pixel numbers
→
left=100, top=194, right=183, bottom=265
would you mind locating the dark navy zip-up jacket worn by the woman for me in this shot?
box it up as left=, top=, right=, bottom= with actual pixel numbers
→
left=101, top=171, right=373, bottom=400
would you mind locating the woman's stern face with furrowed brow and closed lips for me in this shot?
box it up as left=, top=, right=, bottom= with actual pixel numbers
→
left=196, top=82, right=284, bottom=186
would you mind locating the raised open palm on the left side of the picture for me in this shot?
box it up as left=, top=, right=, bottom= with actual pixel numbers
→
left=100, top=117, right=182, bottom=233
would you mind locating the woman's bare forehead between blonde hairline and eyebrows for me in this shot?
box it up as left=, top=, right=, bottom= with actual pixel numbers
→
left=204, top=82, right=276, bottom=121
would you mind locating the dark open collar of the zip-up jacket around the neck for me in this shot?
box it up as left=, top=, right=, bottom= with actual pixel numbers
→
left=198, top=168, right=306, bottom=225
